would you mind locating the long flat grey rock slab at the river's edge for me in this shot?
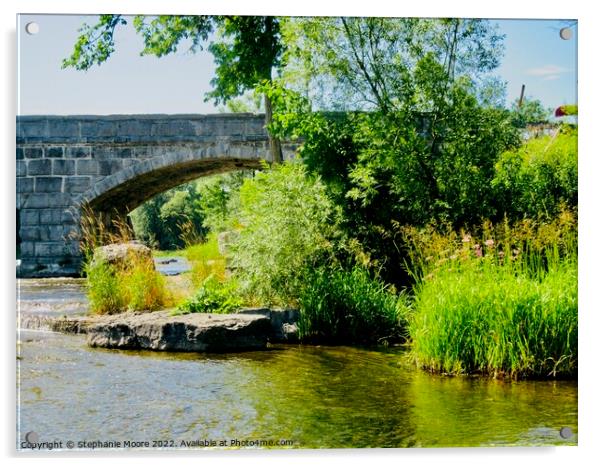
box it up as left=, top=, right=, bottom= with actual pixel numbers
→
left=86, top=311, right=272, bottom=353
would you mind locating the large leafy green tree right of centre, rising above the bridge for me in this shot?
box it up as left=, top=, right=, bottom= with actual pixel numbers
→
left=272, top=18, right=518, bottom=283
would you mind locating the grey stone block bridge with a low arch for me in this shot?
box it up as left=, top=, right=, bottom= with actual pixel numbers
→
left=16, top=114, right=296, bottom=277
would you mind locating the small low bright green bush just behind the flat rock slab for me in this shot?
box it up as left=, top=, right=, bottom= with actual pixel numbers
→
left=172, top=276, right=242, bottom=315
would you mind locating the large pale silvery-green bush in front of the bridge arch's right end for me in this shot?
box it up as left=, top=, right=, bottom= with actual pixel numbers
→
left=231, top=163, right=338, bottom=305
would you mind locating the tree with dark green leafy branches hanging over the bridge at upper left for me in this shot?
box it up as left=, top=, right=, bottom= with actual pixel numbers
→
left=63, top=15, right=284, bottom=163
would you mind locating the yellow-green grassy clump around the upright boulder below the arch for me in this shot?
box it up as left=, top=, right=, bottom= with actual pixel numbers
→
left=85, top=258, right=169, bottom=314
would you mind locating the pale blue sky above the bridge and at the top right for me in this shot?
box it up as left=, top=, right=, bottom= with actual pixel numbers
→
left=17, top=15, right=578, bottom=115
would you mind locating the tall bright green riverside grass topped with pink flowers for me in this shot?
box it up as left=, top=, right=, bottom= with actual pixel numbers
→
left=409, top=211, right=577, bottom=378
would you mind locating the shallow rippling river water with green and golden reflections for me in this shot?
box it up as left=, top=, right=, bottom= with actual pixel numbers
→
left=17, top=272, right=577, bottom=448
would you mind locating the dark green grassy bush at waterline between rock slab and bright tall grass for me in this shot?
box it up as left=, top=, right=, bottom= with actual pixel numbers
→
left=299, top=267, right=408, bottom=343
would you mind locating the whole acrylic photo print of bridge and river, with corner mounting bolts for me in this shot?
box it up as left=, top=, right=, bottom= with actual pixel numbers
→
left=16, top=15, right=578, bottom=451
